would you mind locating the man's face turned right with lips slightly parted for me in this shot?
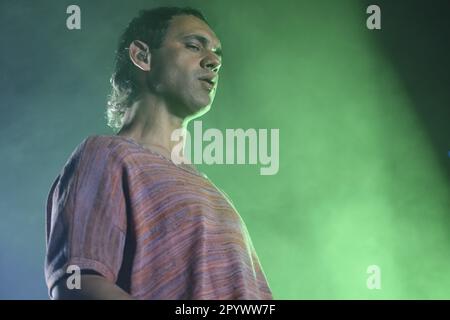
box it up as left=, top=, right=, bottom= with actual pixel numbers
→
left=148, top=15, right=221, bottom=117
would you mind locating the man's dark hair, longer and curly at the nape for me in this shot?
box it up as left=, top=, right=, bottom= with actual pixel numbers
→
left=106, top=7, right=207, bottom=132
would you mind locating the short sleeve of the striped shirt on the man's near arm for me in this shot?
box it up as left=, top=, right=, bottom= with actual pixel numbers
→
left=45, top=137, right=126, bottom=292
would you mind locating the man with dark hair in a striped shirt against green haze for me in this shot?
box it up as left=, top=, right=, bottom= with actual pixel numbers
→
left=45, top=8, right=272, bottom=299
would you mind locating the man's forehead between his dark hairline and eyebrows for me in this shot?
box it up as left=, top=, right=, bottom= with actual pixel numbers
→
left=165, top=15, right=221, bottom=48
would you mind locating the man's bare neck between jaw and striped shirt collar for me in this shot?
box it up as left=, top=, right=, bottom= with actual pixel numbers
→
left=117, top=93, right=187, bottom=162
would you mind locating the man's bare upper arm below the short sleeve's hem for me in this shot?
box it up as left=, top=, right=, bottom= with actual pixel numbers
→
left=51, top=274, right=133, bottom=300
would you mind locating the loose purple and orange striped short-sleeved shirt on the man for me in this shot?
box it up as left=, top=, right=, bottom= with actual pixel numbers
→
left=45, top=136, right=272, bottom=299
